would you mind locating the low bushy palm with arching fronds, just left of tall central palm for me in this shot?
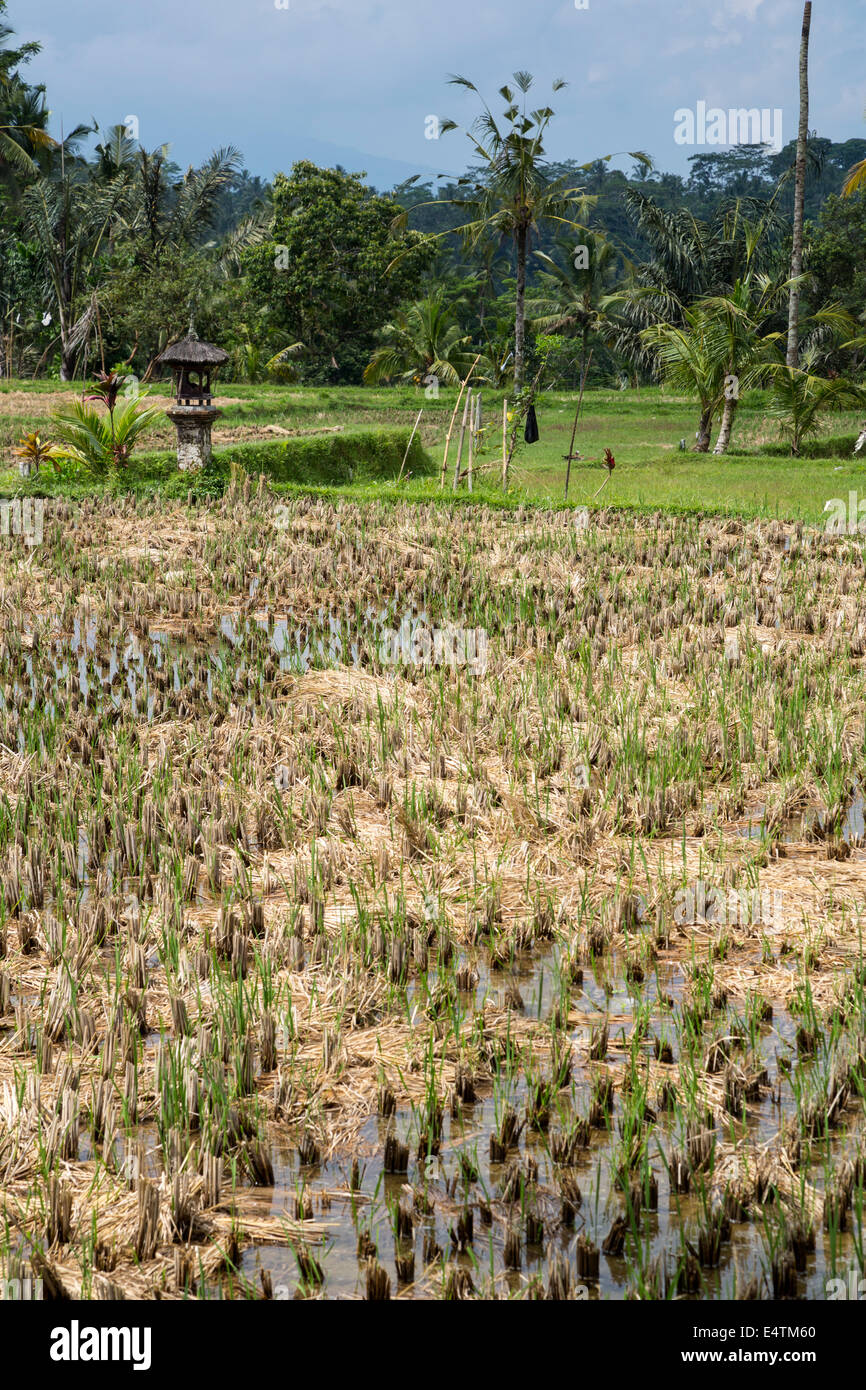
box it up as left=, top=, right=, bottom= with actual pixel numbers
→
left=364, top=289, right=474, bottom=386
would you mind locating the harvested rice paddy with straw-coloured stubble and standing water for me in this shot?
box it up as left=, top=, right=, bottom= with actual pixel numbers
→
left=0, top=464, right=866, bottom=1301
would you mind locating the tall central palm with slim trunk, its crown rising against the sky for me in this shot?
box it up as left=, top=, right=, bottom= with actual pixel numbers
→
left=398, top=72, right=649, bottom=391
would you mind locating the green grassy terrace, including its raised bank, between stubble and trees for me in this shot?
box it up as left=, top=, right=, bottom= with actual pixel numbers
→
left=0, top=381, right=866, bottom=523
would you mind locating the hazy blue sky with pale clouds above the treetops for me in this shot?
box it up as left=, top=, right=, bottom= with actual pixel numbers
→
left=8, top=0, right=866, bottom=186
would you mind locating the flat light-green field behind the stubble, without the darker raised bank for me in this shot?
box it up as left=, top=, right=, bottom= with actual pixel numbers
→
left=0, top=381, right=866, bottom=524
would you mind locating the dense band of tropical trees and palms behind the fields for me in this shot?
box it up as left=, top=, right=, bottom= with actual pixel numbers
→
left=0, top=0, right=866, bottom=452
